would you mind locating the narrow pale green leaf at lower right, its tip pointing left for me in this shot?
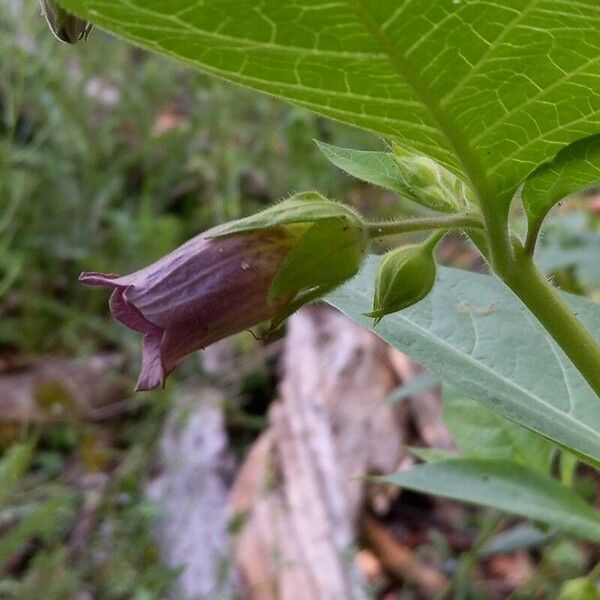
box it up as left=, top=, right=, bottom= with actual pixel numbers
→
left=377, top=458, right=600, bottom=542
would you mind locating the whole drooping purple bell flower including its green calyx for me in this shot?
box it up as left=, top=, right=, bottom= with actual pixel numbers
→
left=80, top=193, right=368, bottom=390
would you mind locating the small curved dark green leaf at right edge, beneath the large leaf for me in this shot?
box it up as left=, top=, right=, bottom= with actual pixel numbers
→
left=521, top=135, right=600, bottom=247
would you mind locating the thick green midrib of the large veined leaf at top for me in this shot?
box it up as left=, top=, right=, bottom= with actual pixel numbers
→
left=346, top=0, right=500, bottom=205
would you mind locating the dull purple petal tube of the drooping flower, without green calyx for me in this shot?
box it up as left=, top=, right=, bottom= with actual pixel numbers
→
left=79, top=227, right=297, bottom=391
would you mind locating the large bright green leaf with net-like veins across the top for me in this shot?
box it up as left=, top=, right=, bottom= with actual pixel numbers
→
left=61, top=0, right=600, bottom=201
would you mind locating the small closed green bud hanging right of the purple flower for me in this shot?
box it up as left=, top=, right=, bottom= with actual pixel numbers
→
left=365, top=234, right=443, bottom=325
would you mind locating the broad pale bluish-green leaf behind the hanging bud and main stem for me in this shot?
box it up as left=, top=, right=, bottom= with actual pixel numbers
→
left=330, top=258, right=600, bottom=461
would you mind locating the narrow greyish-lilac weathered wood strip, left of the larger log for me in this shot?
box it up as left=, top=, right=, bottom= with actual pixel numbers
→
left=148, top=388, right=234, bottom=600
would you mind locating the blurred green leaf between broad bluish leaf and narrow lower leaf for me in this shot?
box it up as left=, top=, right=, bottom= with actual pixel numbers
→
left=444, top=388, right=556, bottom=474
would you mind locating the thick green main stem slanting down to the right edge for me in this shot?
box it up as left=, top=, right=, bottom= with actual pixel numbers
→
left=499, top=244, right=600, bottom=397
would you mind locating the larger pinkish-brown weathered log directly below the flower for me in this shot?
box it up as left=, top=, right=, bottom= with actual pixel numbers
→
left=231, top=307, right=404, bottom=600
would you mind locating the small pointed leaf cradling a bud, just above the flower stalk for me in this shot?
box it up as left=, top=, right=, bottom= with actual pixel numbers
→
left=317, top=142, right=474, bottom=212
